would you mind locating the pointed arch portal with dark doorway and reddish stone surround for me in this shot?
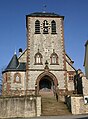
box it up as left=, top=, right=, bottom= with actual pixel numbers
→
left=36, top=72, right=58, bottom=93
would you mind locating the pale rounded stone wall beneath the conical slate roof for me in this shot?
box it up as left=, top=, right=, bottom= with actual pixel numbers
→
left=2, top=71, right=26, bottom=95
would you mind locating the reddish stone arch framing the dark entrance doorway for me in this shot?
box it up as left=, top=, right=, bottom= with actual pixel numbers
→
left=36, top=72, right=58, bottom=93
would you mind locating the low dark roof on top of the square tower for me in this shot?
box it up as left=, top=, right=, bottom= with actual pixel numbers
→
left=26, top=12, right=64, bottom=18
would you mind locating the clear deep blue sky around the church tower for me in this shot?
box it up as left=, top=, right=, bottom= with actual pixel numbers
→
left=0, top=0, right=88, bottom=72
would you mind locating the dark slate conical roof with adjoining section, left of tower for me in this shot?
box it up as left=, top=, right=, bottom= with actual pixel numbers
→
left=2, top=54, right=26, bottom=73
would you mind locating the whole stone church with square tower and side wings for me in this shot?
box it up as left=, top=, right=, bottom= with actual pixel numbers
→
left=2, top=12, right=76, bottom=100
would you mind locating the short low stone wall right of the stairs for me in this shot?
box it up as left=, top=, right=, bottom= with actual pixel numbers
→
left=71, top=97, right=88, bottom=114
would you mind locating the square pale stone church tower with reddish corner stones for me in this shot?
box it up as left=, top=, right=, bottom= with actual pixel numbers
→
left=26, top=12, right=67, bottom=95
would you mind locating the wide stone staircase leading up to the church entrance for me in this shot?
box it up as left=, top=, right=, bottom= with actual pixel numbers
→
left=41, top=92, right=71, bottom=116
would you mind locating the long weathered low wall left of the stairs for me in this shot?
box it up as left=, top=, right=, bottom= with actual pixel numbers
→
left=0, top=96, right=41, bottom=118
